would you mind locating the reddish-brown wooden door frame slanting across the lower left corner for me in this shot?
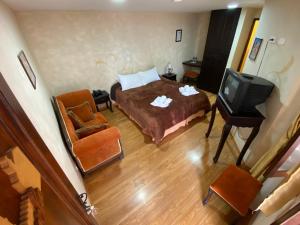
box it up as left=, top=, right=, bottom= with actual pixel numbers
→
left=0, top=73, right=98, bottom=225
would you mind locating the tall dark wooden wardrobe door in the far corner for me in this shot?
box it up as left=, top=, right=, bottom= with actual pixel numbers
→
left=198, top=8, right=241, bottom=93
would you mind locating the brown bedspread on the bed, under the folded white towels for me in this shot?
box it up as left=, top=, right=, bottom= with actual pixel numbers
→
left=113, top=78, right=211, bottom=143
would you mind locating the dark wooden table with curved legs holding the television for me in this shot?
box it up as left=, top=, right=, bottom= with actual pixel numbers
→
left=205, top=97, right=265, bottom=166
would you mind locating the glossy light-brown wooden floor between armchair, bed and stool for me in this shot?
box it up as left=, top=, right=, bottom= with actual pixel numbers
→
left=85, top=95, right=238, bottom=225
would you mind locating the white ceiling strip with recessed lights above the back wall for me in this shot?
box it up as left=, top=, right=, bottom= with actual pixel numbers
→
left=3, top=0, right=264, bottom=12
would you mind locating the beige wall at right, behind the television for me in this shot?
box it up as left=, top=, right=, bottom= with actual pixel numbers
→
left=235, top=0, right=300, bottom=164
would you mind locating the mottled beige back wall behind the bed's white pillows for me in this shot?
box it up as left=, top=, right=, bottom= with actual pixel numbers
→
left=17, top=11, right=209, bottom=95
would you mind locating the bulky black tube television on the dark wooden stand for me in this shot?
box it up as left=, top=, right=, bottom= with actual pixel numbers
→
left=218, top=69, right=274, bottom=114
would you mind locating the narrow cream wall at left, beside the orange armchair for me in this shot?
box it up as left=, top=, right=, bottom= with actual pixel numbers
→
left=0, top=1, right=85, bottom=193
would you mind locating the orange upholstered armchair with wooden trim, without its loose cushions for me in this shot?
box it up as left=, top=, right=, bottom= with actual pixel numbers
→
left=54, top=90, right=123, bottom=174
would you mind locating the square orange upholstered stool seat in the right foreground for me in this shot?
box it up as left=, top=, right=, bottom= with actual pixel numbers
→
left=210, top=165, right=262, bottom=216
